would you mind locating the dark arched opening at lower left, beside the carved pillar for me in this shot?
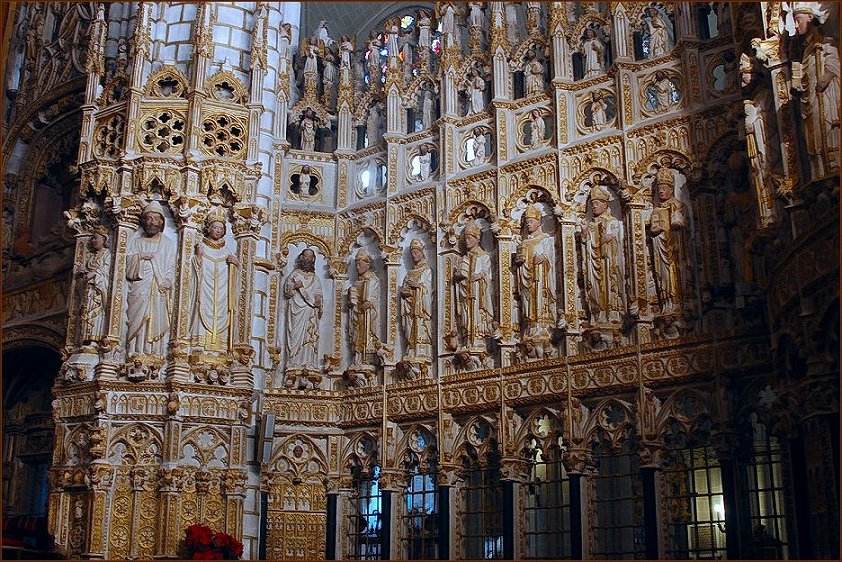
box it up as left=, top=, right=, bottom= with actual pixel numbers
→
left=3, top=345, right=61, bottom=550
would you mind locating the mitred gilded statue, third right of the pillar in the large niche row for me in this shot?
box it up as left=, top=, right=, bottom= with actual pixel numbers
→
left=400, top=238, right=433, bottom=358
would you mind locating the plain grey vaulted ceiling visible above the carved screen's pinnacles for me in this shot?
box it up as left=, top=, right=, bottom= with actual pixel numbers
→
left=301, top=2, right=435, bottom=45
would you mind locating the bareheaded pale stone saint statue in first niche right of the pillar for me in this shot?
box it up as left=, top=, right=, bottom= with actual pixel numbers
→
left=283, top=248, right=324, bottom=380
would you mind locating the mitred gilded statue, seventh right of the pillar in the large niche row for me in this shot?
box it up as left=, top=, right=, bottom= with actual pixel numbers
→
left=649, top=168, right=689, bottom=314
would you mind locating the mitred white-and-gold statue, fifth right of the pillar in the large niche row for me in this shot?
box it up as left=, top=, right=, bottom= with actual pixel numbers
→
left=514, top=205, right=556, bottom=340
